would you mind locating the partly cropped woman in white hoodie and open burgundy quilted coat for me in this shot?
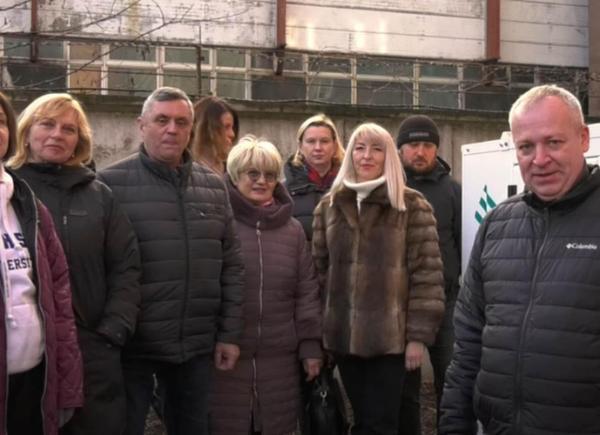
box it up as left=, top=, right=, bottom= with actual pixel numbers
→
left=0, top=93, right=83, bottom=435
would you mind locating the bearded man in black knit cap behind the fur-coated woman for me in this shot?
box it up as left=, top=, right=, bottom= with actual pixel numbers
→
left=396, top=115, right=461, bottom=435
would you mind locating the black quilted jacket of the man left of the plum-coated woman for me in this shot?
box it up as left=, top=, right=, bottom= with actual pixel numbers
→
left=100, top=147, right=243, bottom=364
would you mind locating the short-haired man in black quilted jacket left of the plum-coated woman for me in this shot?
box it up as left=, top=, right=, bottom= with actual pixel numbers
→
left=100, top=88, right=243, bottom=435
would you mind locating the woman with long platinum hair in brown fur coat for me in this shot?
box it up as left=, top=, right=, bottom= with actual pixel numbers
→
left=313, top=123, right=444, bottom=435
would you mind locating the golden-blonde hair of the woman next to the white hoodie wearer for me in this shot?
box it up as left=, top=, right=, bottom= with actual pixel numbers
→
left=7, top=94, right=92, bottom=168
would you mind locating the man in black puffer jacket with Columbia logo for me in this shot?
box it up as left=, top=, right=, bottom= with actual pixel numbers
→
left=439, top=85, right=600, bottom=435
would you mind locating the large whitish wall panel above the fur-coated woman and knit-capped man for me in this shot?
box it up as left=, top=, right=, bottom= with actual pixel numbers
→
left=287, top=0, right=485, bottom=59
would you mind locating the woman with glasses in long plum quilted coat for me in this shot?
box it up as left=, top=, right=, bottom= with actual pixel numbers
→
left=211, top=137, right=321, bottom=435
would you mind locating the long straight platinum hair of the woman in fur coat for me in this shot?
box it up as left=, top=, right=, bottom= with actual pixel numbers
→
left=330, top=122, right=406, bottom=211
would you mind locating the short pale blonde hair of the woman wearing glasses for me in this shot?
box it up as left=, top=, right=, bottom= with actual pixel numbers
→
left=227, top=134, right=283, bottom=184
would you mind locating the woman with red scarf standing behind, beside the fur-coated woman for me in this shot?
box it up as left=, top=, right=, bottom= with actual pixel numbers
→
left=284, top=114, right=344, bottom=241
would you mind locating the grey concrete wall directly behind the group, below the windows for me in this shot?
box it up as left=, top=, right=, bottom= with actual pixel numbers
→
left=28, top=98, right=508, bottom=179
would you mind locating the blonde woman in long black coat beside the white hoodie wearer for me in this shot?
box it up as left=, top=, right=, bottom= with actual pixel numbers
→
left=8, top=94, right=140, bottom=435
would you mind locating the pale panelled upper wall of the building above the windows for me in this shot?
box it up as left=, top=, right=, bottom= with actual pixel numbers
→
left=0, top=0, right=589, bottom=67
